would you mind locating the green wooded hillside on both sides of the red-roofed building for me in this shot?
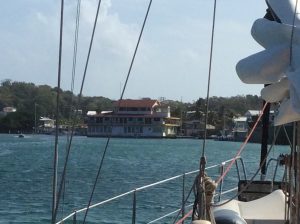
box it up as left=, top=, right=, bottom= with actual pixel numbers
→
left=0, top=80, right=262, bottom=133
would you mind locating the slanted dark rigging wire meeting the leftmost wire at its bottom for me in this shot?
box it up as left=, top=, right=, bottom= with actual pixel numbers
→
left=53, top=0, right=101, bottom=221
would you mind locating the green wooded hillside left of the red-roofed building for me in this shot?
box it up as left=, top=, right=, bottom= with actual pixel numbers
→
left=0, top=80, right=112, bottom=133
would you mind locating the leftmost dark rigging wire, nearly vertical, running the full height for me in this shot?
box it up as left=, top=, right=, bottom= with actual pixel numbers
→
left=52, top=0, right=64, bottom=224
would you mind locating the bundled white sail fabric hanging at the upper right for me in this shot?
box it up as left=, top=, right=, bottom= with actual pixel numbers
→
left=236, top=0, right=300, bottom=125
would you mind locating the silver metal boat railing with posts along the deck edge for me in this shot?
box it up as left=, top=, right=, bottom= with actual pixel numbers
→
left=56, top=157, right=247, bottom=224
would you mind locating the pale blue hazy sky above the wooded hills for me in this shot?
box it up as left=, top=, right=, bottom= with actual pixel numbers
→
left=0, top=0, right=266, bottom=102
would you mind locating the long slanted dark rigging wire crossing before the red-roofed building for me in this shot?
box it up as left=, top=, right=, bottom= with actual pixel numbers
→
left=83, top=0, right=152, bottom=224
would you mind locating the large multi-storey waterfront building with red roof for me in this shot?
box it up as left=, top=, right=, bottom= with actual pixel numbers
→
left=87, top=98, right=180, bottom=137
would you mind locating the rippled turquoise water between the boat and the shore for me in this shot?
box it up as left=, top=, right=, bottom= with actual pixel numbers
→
left=0, top=135, right=289, bottom=223
